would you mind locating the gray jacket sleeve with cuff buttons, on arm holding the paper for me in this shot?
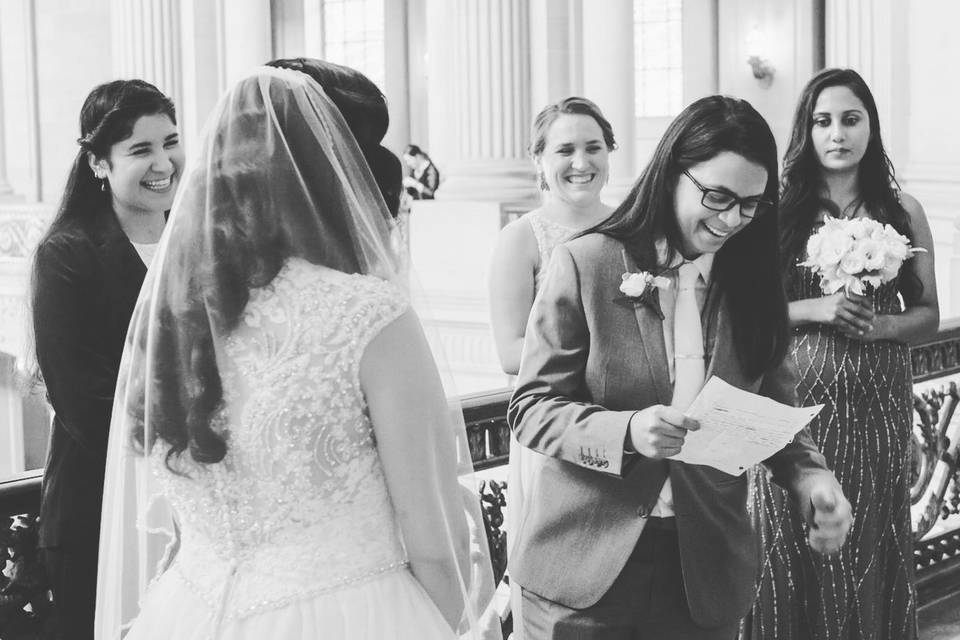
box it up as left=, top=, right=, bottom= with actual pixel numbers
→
left=507, top=245, right=634, bottom=475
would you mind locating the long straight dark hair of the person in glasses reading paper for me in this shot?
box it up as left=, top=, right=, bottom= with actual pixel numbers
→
left=584, top=95, right=788, bottom=376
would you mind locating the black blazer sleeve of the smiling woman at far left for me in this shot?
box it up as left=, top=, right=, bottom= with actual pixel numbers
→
left=33, top=241, right=117, bottom=456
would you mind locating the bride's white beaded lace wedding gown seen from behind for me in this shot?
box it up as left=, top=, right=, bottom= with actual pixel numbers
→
left=126, top=259, right=454, bottom=640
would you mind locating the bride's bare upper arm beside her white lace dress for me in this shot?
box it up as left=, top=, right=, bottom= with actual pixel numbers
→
left=360, top=310, right=470, bottom=628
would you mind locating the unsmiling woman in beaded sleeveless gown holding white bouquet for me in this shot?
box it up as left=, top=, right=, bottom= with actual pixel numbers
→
left=742, top=69, right=939, bottom=640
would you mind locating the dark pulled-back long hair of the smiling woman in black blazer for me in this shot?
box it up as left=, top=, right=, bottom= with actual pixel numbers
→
left=26, top=80, right=177, bottom=388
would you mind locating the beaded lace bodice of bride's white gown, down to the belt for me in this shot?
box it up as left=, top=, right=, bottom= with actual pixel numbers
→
left=152, top=259, right=407, bottom=619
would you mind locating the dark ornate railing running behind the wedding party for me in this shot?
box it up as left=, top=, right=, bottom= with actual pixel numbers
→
left=0, top=321, right=960, bottom=640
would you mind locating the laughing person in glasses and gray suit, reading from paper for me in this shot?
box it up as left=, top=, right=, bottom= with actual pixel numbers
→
left=508, top=96, right=851, bottom=640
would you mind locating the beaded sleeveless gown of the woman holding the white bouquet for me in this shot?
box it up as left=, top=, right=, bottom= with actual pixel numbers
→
left=741, top=258, right=917, bottom=640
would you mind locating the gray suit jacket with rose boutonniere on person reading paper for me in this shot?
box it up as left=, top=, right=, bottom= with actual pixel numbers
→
left=508, top=234, right=830, bottom=627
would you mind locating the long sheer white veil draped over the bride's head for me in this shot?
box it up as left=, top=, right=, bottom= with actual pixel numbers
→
left=96, top=67, right=499, bottom=639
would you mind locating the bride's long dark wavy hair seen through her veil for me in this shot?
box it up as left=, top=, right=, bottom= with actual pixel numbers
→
left=131, top=67, right=387, bottom=469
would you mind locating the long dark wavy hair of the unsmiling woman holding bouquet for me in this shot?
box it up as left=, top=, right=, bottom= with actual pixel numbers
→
left=780, top=69, right=922, bottom=287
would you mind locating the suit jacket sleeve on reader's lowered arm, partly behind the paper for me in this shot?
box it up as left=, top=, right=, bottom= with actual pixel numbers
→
left=760, top=358, right=836, bottom=515
